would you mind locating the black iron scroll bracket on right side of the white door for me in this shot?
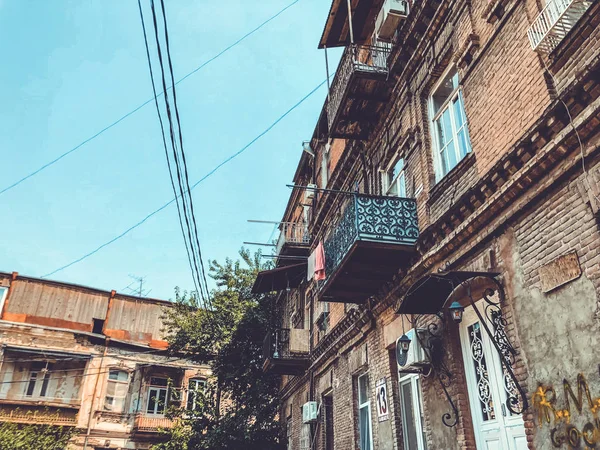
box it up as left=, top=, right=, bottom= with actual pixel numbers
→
left=465, top=276, right=528, bottom=415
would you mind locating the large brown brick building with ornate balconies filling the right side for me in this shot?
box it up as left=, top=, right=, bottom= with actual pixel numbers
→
left=254, top=0, right=600, bottom=450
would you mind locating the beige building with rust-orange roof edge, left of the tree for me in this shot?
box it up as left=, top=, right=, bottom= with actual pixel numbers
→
left=0, top=273, right=210, bottom=450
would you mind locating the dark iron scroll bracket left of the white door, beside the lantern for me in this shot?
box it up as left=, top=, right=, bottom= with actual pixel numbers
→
left=412, top=313, right=458, bottom=428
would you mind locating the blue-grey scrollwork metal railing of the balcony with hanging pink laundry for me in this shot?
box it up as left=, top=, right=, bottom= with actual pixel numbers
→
left=321, top=194, right=419, bottom=288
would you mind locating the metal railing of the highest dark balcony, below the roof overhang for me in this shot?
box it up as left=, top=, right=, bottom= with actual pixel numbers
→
left=327, top=45, right=391, bottom=134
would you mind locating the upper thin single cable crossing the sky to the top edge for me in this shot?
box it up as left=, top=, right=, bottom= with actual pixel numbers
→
left=0, top=0, right=300, bottom=195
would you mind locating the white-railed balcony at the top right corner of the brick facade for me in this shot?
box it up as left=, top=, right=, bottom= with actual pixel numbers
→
left=527, top=0, right=593, bottom=54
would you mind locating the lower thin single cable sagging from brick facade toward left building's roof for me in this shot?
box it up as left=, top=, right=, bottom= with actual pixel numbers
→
left=41, top=79, right=327, bottom=278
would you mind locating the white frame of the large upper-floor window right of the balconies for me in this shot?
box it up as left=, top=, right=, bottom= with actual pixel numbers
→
left=429, top=66, right=473, bottom=181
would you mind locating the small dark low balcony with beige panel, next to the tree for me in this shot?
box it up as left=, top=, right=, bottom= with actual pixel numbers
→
left=263, top=328, right=310, bottom=375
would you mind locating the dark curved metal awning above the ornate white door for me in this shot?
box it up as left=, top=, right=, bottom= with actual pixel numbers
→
left=397, top=271, right=500, bottom=314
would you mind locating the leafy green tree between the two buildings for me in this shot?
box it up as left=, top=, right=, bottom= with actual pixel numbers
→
left=153, top=248, right=282, bottom=450
